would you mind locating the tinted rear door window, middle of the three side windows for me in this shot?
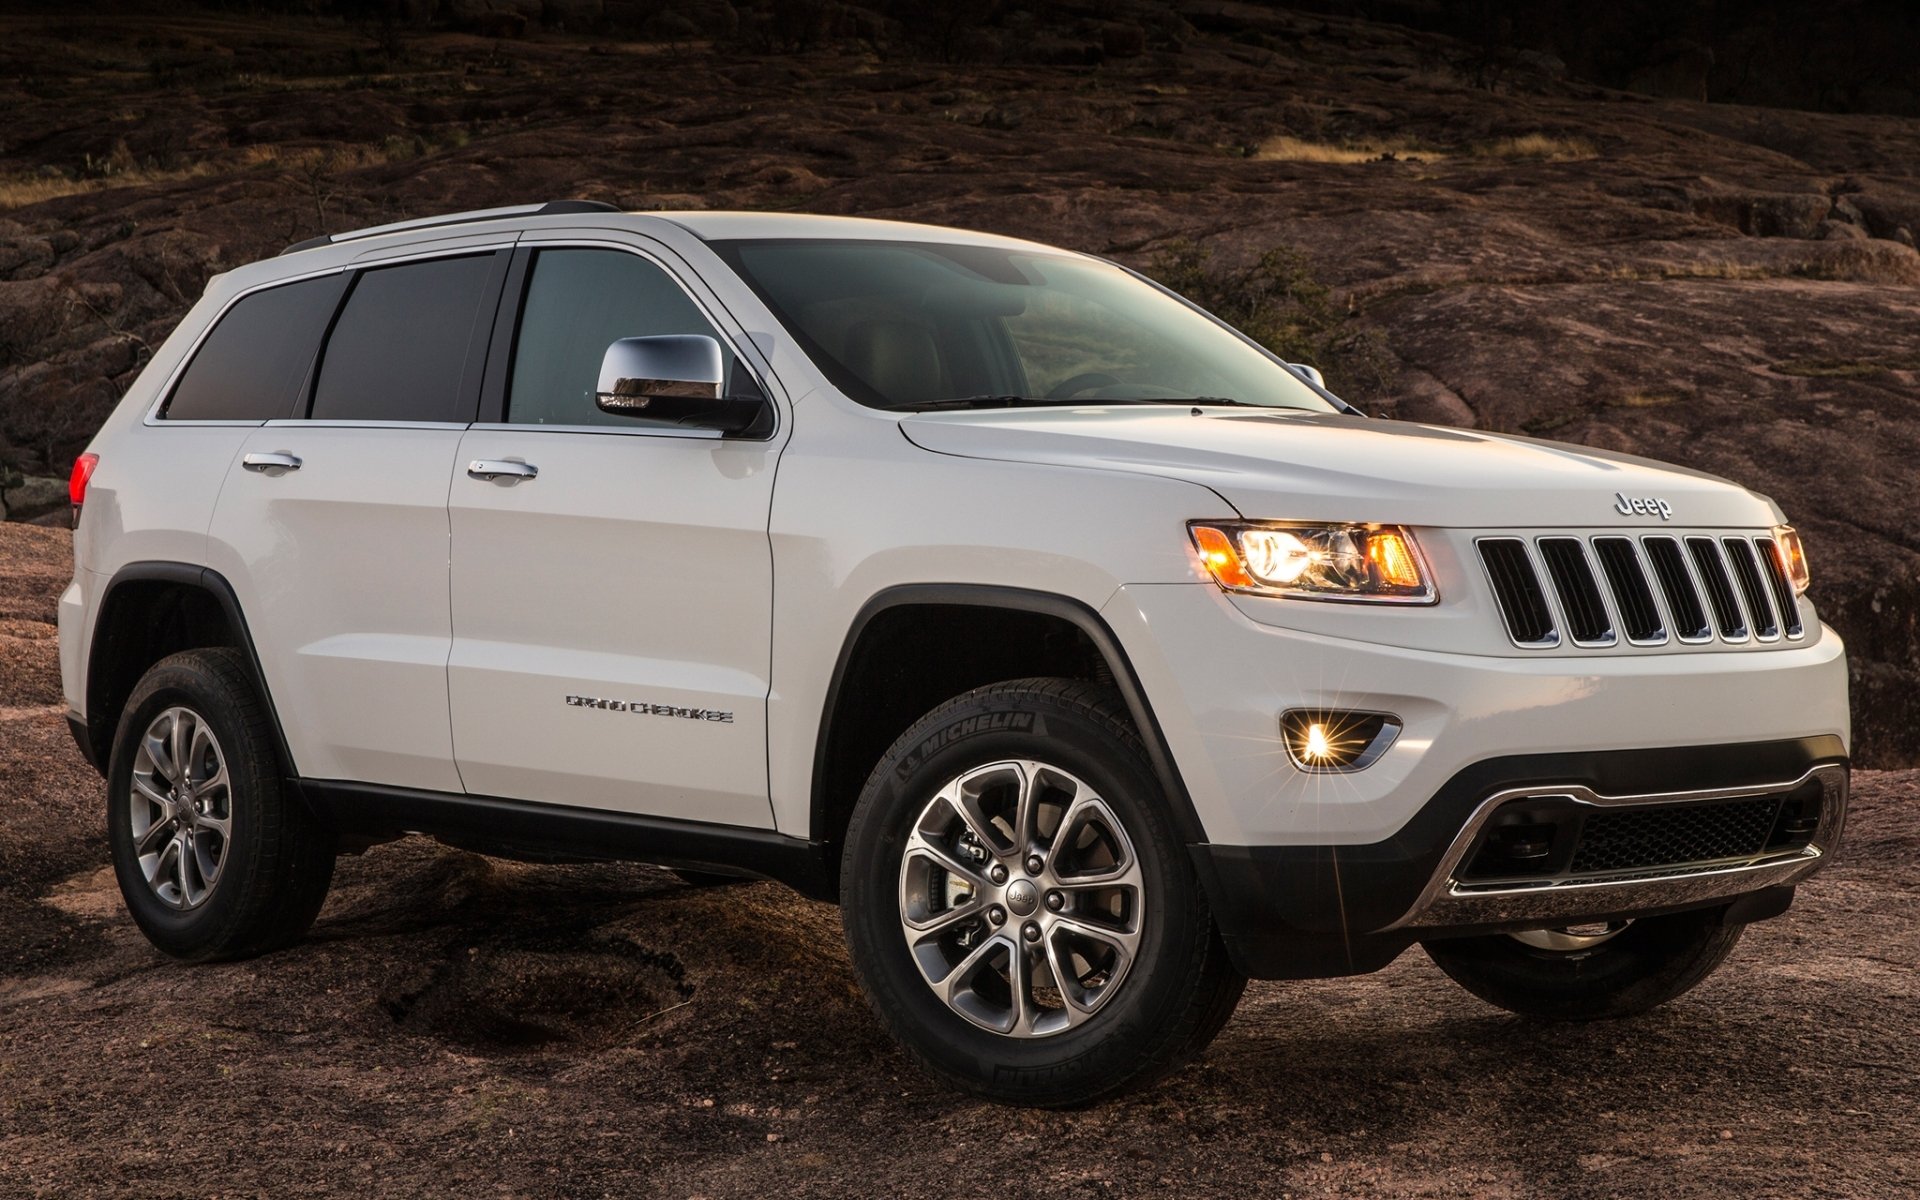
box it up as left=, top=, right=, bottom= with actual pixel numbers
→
left=311, top=253, right=493, bottom=422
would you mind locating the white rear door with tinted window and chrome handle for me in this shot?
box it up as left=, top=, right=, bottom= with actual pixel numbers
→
left=209, top=248, right=511, bottom=793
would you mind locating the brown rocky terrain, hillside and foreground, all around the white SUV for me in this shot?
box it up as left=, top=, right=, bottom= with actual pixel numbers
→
left=0, top=0, right=1920, bottom=1196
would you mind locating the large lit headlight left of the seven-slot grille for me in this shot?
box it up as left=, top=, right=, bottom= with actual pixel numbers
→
left=1187, top=520, right=1438, bottom=605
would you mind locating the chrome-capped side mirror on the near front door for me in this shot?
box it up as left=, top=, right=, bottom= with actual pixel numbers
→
left=593, top=334, right=770, bottom=434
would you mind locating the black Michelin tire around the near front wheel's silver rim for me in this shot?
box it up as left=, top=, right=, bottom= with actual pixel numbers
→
left=841, top=680, right=1246, bottom=1108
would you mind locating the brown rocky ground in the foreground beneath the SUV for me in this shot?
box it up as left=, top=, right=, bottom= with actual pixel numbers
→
left=0, top=524, right=1920, bottom=1200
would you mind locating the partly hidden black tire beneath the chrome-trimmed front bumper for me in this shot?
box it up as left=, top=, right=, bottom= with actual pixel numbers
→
left=1425, top=908, right=1741, bottom=1021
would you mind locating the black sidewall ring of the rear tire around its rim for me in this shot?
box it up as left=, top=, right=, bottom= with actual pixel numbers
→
left=108, top=655, right=271, bottom=958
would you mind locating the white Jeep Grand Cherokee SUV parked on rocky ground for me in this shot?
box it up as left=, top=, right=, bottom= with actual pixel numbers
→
left=60, top=202, right=1849, bottom=1104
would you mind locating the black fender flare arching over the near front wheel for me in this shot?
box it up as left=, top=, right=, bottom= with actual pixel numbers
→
left=808, top=584, right=1206, bottom=845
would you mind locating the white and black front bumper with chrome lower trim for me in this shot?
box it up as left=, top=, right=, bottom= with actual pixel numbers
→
left=1104, top=584, right=1849, bottom=977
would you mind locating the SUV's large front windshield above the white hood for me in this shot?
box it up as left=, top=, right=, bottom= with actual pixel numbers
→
left=712, top=238, right=1334, bottom=413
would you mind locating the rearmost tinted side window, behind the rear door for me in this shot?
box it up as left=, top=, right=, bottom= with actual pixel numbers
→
left=159, top=275, right=346, bottom=420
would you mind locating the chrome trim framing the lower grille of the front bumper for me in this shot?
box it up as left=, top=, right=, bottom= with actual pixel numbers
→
left=1386, top=762, right=1847, bottom=929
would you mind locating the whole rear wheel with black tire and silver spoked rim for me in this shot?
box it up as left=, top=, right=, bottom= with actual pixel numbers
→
left=108, top=649, right=334, bottom=960
